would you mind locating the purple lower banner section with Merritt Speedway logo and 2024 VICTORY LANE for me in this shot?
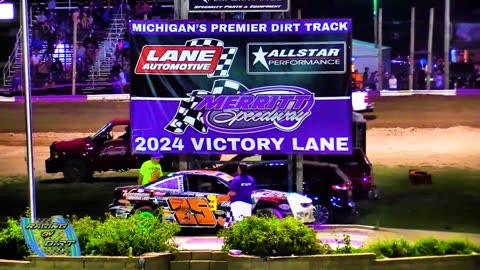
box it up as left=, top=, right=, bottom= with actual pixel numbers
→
left=130, top=80, right=352, bottom=154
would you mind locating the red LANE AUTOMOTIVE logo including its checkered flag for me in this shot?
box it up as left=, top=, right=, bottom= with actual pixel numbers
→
left=135, top=38, right=238, bottom=77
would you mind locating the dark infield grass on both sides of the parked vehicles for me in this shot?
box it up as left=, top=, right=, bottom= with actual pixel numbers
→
left=0, top=166, right=480, bottom=233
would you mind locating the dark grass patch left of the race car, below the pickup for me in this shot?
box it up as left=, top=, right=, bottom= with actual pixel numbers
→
left=0, top=171, right=137, bottom=219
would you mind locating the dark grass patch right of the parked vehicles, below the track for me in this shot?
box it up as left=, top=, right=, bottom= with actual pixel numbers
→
left=358, top=166, right=480, bottom=233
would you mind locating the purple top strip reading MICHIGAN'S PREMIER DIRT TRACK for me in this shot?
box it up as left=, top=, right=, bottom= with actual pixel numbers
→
left=130, top=19, right=352, bottom=35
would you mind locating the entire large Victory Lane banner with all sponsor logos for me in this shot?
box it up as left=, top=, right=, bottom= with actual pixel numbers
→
left=130, top=19, right=352, bottom=154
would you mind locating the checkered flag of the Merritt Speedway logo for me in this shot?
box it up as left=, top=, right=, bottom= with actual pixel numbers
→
left=165, top=80, right=248, bottom=135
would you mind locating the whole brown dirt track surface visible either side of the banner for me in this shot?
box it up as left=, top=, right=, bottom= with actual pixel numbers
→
left=0, top=96, right=480, bottom=176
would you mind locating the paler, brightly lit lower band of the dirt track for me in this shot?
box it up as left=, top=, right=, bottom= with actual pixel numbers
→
left=0, top=127, right=480, bottom=176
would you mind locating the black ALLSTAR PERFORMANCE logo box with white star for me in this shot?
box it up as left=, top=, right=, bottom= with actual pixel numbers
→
left=247, top=42, right=347, bottom=75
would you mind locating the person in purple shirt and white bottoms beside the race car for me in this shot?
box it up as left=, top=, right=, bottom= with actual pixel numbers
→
left=228, top=163, right=257, bottom=223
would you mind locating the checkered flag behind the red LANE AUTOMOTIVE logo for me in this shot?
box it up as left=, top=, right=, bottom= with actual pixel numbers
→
left=185, top=38, right=238, bottom=78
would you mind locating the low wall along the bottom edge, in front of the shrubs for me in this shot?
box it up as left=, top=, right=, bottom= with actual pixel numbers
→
left=0, top=251, right=480, bottom=270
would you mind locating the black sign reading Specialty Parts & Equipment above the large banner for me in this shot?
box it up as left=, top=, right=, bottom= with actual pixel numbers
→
left=188, top=0, right=290, bottom=13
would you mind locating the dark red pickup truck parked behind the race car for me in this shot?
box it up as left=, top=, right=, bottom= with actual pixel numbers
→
left=45, top=119, right=220, bottom=182
